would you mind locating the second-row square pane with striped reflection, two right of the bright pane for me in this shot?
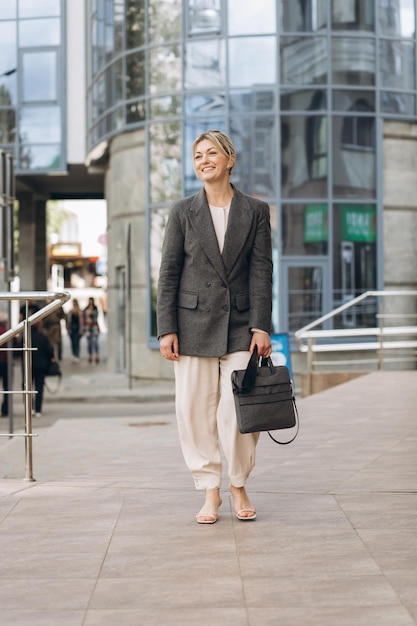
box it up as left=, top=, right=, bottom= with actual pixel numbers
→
left=332, top=37, right=375, bottom=86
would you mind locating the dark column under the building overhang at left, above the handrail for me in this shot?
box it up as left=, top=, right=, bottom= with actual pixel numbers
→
left=17, top=192, right=48, bottom=291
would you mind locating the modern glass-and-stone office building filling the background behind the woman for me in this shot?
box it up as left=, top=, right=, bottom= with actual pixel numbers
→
left=0, top=0, right=417, bottom=377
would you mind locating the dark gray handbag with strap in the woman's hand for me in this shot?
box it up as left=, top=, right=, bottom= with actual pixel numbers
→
left=232, top=347, right=299, bottom=445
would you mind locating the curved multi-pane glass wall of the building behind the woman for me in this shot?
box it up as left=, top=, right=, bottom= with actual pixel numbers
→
left=87, top=0, right=417, bottom=333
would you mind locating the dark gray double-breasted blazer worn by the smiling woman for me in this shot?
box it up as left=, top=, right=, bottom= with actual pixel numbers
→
left=157, top=187, right=272, bottom=357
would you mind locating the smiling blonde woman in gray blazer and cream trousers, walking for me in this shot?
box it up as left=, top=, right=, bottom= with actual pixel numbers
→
left=158, top=130, right=272, bottom=524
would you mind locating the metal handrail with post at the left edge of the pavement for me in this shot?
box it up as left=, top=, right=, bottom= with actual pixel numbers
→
left=0, top=291, right=71, bottom=482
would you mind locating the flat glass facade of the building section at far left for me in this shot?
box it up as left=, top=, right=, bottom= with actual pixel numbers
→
left=0, top=0, right=66, bottom=175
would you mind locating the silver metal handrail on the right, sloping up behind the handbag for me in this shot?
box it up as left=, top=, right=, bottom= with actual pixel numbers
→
left=294, top=289, right=417, bottom=392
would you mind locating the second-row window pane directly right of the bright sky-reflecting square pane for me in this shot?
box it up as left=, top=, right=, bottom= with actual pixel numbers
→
left=281, top=37, right=327, bottom=85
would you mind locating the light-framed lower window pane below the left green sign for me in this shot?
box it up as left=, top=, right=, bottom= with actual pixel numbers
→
left=288, top=265, right=323, bottom=332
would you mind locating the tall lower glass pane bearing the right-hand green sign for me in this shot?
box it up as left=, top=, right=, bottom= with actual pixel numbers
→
left=333, top=204, right=377, bottom=328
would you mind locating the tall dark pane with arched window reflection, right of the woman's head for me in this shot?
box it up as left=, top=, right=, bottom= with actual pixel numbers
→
left=281, top=115, right=328, bottom=198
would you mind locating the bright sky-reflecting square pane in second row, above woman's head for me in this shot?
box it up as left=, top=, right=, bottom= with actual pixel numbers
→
left=229, top=37, right=277, bottom=87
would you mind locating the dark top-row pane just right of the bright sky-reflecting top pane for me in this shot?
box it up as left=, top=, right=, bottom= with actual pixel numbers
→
left=281, top=0, right=327, bottom=32
